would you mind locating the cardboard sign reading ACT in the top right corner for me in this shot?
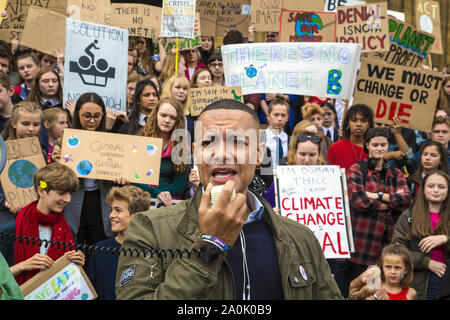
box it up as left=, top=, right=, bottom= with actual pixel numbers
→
left=415, top=0, right=442, bottom=54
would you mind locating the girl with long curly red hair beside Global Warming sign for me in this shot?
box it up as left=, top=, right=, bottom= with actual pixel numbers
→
left=136, top=97, right=189, bottom=206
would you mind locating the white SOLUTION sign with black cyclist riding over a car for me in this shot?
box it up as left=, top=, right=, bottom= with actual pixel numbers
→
left=63, top=18, right=128, bottom=111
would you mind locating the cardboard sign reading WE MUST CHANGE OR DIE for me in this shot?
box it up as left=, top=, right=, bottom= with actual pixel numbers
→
left=353, top=58, right=442, bottom=132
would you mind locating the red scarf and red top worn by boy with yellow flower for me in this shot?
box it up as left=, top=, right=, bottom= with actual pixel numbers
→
left=14, top=200, right=75, bottom=285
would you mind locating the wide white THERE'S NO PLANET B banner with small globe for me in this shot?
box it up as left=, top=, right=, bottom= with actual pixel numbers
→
left=221, top=42, right=361, bottom=99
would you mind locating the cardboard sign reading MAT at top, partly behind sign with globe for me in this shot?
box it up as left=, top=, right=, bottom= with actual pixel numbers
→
left=251, top=0, right=324, bottom=32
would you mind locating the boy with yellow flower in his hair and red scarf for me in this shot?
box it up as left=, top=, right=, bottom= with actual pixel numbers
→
left=0, top=163, right=85, bottom=285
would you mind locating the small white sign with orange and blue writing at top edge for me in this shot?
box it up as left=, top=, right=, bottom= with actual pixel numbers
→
left=161, top=0, right=196, bottom=39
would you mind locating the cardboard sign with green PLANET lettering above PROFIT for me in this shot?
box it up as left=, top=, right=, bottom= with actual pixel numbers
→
left=369, top=17, right=435, bottom=67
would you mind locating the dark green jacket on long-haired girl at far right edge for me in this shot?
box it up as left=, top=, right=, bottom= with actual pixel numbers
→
left=391, top=209, right=450, bottom=300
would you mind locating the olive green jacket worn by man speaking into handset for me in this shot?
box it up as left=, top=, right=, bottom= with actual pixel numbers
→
left=116, top=188, right=343, bottom=300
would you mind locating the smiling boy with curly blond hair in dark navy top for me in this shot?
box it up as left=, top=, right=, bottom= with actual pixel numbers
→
left=87, top=185, right=151, bottom=300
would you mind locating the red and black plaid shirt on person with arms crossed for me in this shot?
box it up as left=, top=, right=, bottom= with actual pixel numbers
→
left=347, top=163, right=412, bottom=265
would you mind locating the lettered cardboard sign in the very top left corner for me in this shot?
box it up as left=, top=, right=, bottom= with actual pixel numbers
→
left=0, top=0, right=67, bottom=42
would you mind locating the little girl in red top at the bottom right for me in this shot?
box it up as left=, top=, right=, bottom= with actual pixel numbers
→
left=378, top=243, right=417, bottom=300
